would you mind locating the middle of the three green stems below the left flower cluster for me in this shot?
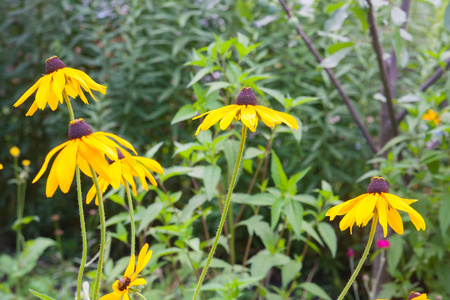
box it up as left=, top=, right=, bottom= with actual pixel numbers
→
left=89, top=166, right=106, bottom=300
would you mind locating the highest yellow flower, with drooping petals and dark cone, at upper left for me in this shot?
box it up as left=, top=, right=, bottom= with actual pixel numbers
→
left=14, top=56, right=106, bottom=116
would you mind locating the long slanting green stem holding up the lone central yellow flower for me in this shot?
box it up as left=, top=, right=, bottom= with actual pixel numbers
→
left=192, top=125, right=247, bottom=300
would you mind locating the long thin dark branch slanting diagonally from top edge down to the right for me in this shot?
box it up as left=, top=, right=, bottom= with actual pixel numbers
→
left=279, top=0, right=378, bottom=153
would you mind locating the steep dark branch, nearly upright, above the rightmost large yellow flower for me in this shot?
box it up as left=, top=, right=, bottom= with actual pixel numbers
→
left=367, top=0, right=398, bottom=136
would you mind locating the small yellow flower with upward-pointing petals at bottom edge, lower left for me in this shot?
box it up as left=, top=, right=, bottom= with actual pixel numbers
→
left=99, top=244, right=152, bottom=300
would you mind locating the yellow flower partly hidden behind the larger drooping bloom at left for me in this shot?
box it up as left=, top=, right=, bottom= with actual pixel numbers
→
left=86, top=149, right=164, bottom=205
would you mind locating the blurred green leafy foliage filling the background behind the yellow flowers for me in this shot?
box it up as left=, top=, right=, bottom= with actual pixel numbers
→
left=0, top=0, right=450, bottom=299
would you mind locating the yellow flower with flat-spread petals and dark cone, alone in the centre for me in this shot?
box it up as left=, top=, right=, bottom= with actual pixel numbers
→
left=193, top=87, right=298, bottom=135
